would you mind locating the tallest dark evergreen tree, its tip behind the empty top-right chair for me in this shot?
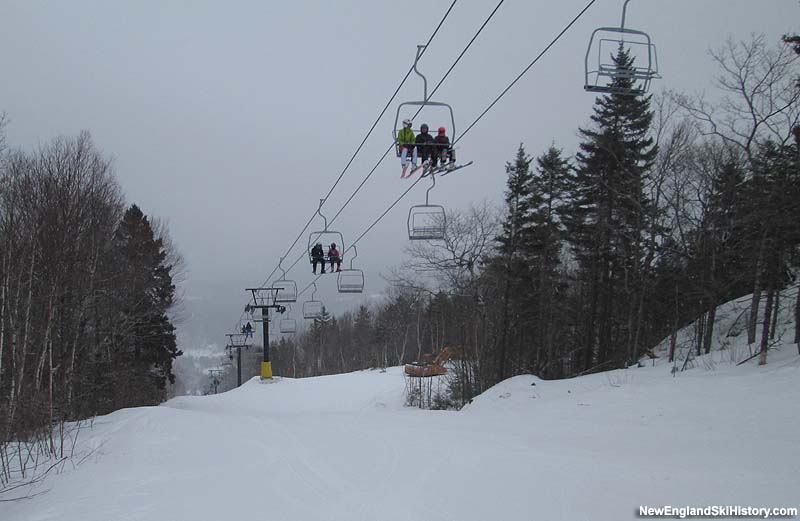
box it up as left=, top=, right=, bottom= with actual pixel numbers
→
left=567, top=49, right=657, bottom=370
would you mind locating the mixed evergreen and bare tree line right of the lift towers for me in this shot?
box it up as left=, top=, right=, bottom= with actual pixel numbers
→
left=234, top=36, right=800, bottom=406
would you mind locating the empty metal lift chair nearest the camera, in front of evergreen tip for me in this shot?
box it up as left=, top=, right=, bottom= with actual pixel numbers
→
left=583, top=0, right=661, bottom=96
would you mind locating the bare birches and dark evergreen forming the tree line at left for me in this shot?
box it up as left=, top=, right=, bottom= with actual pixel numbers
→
left=0, top=125, right=182, bottom=483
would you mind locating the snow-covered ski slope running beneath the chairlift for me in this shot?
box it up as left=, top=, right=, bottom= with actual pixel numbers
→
left=0, top=300, right=800, bottom=521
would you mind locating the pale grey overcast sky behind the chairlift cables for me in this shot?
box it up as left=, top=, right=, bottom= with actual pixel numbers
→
left=0, top=0, right=800, bottom=350
